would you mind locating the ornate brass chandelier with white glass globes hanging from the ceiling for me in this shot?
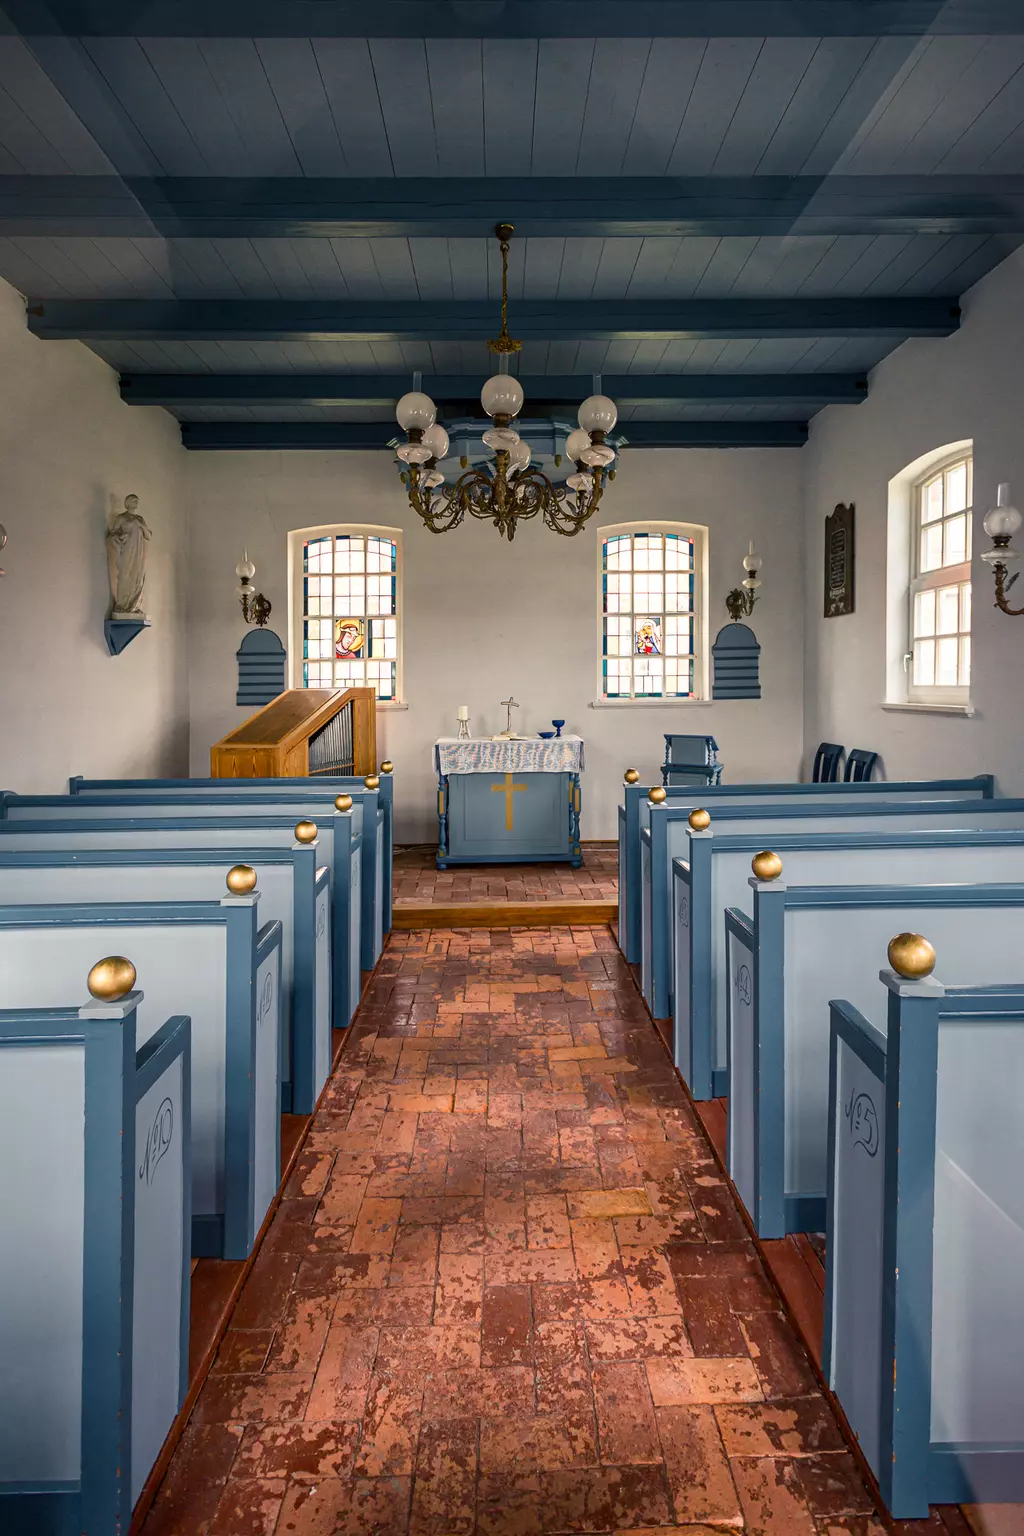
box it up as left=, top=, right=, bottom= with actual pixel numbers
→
left=389, top=224, right=619, bottom=542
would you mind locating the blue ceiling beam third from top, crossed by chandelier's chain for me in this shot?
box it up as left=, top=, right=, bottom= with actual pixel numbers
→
left=28, top=298, right=960, bottom=341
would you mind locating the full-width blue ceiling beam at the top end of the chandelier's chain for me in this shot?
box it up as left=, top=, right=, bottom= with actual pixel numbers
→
left=0, top=176, right=1024, bottom=240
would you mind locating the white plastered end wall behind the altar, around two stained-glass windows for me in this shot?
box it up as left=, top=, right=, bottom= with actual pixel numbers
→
left=187, top=449, right=803, bottom=842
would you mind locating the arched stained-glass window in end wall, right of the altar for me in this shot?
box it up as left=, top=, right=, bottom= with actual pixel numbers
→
left=600, top=524, right=703, bottom=699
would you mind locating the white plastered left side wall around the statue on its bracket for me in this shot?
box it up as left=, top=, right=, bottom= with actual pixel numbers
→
left=0, top=283, right=189, bottom=793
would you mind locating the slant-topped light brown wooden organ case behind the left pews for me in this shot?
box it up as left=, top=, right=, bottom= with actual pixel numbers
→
left=210, top=688, right=376, bottom=779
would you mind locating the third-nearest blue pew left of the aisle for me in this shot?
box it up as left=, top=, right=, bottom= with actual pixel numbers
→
left=0, top=837, right=332, bottom=1115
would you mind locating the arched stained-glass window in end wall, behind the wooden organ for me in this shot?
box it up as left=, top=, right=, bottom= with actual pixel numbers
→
left=296, top=527, right=402, bottom=700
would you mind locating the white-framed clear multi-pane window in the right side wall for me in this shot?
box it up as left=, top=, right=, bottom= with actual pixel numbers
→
left=907, top=453, right=973, bottom=703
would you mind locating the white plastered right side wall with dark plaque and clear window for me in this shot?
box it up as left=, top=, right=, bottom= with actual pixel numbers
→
left=803, top=252, right=1024, bottom=794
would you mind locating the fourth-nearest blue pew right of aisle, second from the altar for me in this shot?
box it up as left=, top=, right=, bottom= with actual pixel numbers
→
left=640, top=785, right=1024, bottom=1018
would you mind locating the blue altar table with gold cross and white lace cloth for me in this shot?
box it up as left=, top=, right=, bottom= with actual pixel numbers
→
left=434, top=736, right=583, bottom=869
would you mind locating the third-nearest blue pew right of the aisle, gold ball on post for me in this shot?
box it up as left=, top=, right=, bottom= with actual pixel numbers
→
left=672, top=829, right=1024, bottom=1100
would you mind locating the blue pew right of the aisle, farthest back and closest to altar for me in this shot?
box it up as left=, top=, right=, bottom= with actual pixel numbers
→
left=619, top=770, right=995, bottom=965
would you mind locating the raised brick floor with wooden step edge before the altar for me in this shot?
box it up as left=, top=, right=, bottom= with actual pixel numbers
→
left=395, top=843, right=619, bottom=906
